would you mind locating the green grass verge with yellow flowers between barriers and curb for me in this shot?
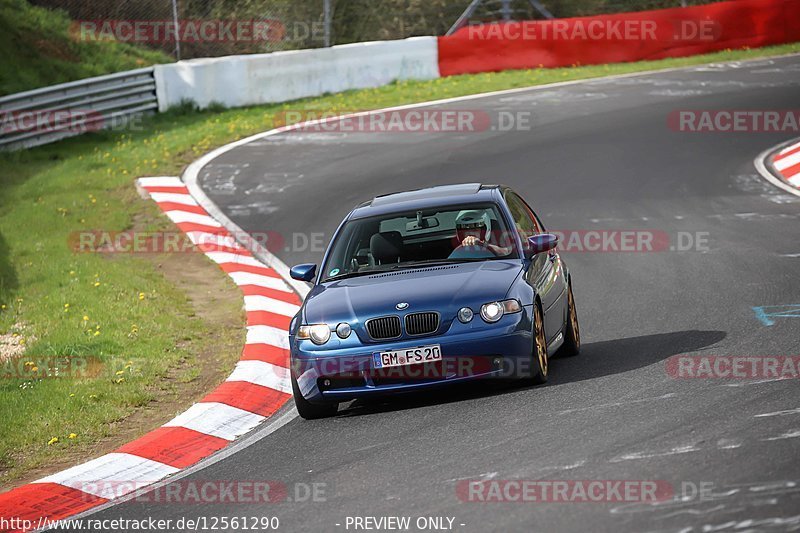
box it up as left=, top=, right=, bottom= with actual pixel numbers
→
left=0, top=44, right=800, bottom=481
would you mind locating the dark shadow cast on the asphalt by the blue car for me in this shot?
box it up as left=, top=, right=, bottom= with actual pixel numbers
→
left=337, top=330, right=726, bottom=417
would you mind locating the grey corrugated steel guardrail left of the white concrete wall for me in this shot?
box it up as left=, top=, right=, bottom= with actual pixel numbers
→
left=0, top=67, right=158, bottom=150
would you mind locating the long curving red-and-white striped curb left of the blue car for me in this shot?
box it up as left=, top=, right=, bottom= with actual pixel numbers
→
left=0, top=177, right=301, bottom=532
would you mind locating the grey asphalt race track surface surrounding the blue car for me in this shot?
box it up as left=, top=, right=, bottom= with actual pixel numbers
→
left=78, top=56, right=800, bottom=532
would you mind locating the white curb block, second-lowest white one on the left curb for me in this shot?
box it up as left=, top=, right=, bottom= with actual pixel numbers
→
left=164, top=402, right=265, bottom=440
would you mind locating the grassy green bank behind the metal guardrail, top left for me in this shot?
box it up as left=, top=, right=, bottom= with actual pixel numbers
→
left=0, top=0, right=172, bottom=95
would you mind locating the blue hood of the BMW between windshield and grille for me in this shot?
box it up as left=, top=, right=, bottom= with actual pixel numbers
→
left=304, top=260, right=522, bottom=324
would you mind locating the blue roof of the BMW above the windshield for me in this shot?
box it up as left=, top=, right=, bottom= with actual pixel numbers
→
left=349, top=183, right=499, bottom=219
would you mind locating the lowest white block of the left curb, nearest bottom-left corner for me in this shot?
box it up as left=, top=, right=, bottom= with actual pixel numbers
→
left=34, top=453, right=180, bottom=499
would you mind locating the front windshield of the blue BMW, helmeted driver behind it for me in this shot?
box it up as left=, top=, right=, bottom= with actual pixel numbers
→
left=322, top=204, right=518, bottom=281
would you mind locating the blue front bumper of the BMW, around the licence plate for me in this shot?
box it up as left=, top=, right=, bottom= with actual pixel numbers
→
left=291, top=306, right=533, bottom=403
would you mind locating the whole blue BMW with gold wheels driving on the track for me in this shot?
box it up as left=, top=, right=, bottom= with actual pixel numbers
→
left=289, top=183, right=580, bottom=419
